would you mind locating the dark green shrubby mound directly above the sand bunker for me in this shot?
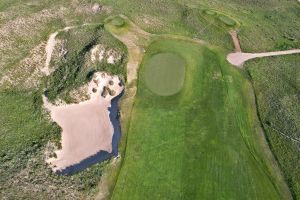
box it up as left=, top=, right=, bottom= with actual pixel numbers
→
left=47, top=25, right=126, bottom=103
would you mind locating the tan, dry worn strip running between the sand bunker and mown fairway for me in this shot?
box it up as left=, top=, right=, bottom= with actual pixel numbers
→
left=95, top=15, right=153, bottom=200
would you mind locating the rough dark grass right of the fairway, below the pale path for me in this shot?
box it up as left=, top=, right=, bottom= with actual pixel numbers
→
left=246, top=55, right=300, bottom=199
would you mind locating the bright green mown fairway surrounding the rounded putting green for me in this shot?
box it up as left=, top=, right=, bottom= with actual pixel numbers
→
left=112, top=39, right=286, bottom=200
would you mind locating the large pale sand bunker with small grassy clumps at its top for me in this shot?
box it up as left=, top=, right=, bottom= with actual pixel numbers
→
left=43, top=72, right=123, bottom=172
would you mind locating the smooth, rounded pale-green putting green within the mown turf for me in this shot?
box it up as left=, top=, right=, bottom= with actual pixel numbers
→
left=144, top=53, right=185, bottom=96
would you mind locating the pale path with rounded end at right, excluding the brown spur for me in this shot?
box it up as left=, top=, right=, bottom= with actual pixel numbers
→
left=227, top=49, right=300, bottom=68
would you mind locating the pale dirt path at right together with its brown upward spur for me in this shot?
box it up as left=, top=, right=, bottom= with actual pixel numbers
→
left=227, top=31, right=300, bottom=69
